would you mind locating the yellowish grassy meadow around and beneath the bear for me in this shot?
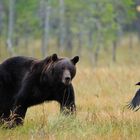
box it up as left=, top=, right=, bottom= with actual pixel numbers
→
left=0, top=37, right=140, bottom=140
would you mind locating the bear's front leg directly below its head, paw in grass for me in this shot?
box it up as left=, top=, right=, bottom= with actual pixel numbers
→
left=60, top=85, right=76, bottom=115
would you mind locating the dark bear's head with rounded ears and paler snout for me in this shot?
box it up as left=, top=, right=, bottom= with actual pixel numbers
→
left=52, top=54, right=79, bottom=86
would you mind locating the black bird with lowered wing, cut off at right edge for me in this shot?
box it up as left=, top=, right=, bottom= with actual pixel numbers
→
left=127, top=82, right=140, bottom=111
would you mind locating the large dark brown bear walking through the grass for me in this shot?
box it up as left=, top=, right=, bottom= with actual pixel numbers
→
left=0, top=54, right=79, bottom=127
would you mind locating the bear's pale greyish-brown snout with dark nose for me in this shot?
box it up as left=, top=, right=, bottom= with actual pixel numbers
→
left=62, top=69, right=71, bottom=85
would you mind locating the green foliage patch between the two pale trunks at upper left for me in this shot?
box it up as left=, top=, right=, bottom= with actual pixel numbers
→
left=16, top=0, right=39, bottom=35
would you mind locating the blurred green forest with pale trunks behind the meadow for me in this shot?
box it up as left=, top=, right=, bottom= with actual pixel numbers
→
left=0, top=0, right=136, bottom=62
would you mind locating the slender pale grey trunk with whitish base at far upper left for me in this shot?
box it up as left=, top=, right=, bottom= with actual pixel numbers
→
left=7, top=0, right=15, bottom=55
